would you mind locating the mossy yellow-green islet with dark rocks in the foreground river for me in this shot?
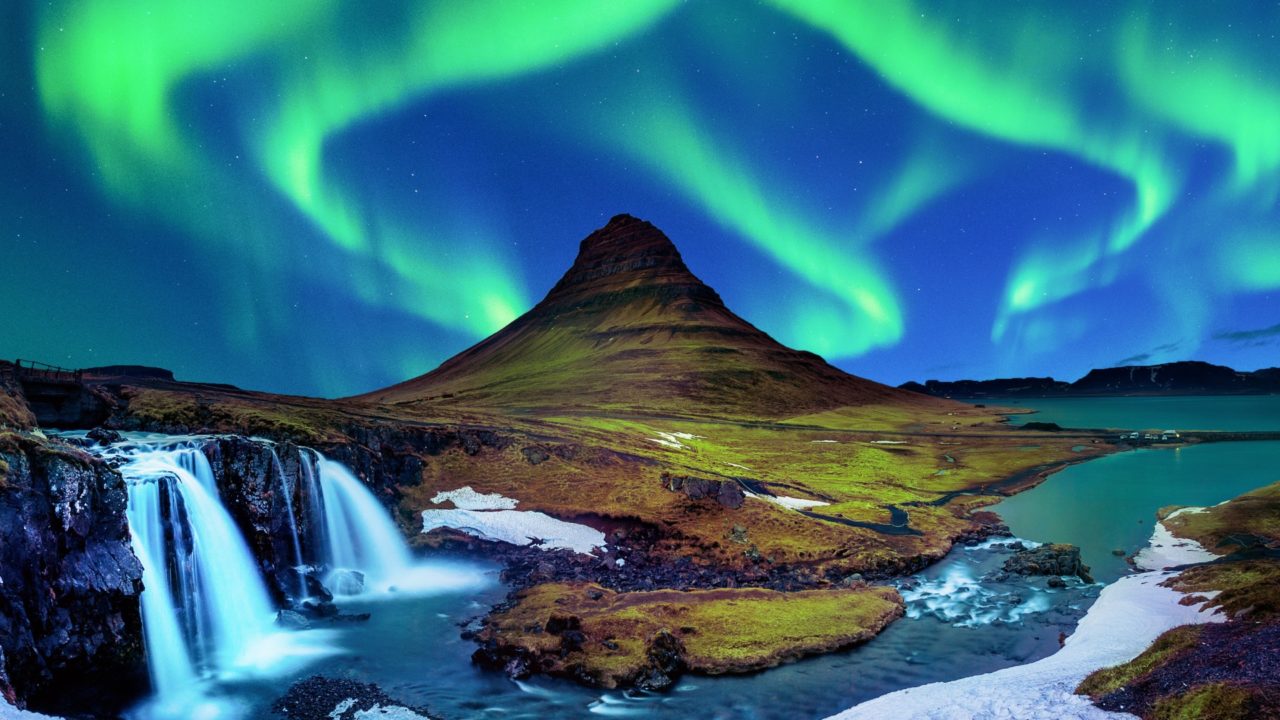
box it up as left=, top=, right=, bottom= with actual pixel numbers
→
left=480, top=576, right=902, bottom=687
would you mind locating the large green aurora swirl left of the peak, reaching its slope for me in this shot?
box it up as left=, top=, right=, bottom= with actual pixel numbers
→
left=36, top=0, right=673, bottom=338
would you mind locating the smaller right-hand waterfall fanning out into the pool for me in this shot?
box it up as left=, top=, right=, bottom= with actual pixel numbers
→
left=312, top=452, right=413, bottom=592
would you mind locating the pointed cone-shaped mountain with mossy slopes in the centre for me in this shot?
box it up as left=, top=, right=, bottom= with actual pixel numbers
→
left=358, top=215, right=928, bottom=418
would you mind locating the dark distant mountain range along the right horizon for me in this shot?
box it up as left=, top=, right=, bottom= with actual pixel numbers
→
left=901, top=361, right=1280, bottom=398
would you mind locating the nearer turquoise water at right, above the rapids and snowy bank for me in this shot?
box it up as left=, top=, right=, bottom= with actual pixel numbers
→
left=992, top=438, right=1280, bottom=583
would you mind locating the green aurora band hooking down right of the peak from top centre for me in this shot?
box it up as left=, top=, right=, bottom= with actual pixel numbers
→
left=772, top=0, right=1180, bottom=342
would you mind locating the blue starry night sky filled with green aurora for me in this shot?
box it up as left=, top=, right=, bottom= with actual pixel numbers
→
left=0, top=0, right=1280, bottom=396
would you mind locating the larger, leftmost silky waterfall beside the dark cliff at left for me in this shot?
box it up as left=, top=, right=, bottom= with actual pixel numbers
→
left=120, top=447, right=274, bottom=696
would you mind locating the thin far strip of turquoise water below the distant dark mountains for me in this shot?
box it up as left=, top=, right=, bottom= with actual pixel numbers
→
left=987, top=395, right=1280, bottom=427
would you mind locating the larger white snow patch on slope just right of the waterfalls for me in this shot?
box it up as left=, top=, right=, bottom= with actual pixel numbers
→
left=422, top=509, right=604, bottom=555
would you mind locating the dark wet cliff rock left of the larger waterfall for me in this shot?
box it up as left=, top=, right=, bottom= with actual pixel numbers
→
left=0, top=434, right=146, bottom=712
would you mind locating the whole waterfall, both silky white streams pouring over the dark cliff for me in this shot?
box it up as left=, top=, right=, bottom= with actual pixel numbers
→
left=69, top=433, right=476, bottom=719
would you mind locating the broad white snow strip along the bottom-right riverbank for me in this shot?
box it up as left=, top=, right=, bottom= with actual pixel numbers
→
left=833, top=520, right=1224, bottom=720
